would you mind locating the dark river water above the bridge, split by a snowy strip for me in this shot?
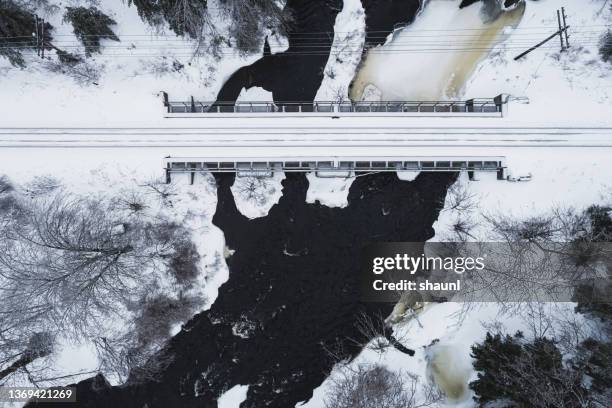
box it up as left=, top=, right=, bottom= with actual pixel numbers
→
left=217, top=0, right=421, bottom=103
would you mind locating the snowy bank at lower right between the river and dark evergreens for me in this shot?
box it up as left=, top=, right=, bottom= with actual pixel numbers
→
left=296, top=302, right=588, bottom=408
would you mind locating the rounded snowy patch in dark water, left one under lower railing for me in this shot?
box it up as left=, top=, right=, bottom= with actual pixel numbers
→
left=232, top=172, right=285, bottom=219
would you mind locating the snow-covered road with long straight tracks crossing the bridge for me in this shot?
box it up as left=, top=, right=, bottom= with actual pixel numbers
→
left=0, top=126, right=612, bottom=150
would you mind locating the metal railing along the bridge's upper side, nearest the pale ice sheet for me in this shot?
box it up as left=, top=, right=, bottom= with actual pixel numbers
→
left=166, top=97, right=504, bottom=116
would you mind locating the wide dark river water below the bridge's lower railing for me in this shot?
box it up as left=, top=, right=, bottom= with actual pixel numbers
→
left=28, top=173, right=455, bottom=408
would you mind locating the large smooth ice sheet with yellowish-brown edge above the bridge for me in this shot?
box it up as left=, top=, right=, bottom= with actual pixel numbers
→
left=351, top=0, right=525, bottom=101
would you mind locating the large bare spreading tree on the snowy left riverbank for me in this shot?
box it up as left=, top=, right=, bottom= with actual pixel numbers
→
left=0, top=191, right=184, bottom=382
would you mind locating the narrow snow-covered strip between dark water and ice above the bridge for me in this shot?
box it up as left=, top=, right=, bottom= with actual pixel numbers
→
left=315, top=0, right=366, bottom=101
